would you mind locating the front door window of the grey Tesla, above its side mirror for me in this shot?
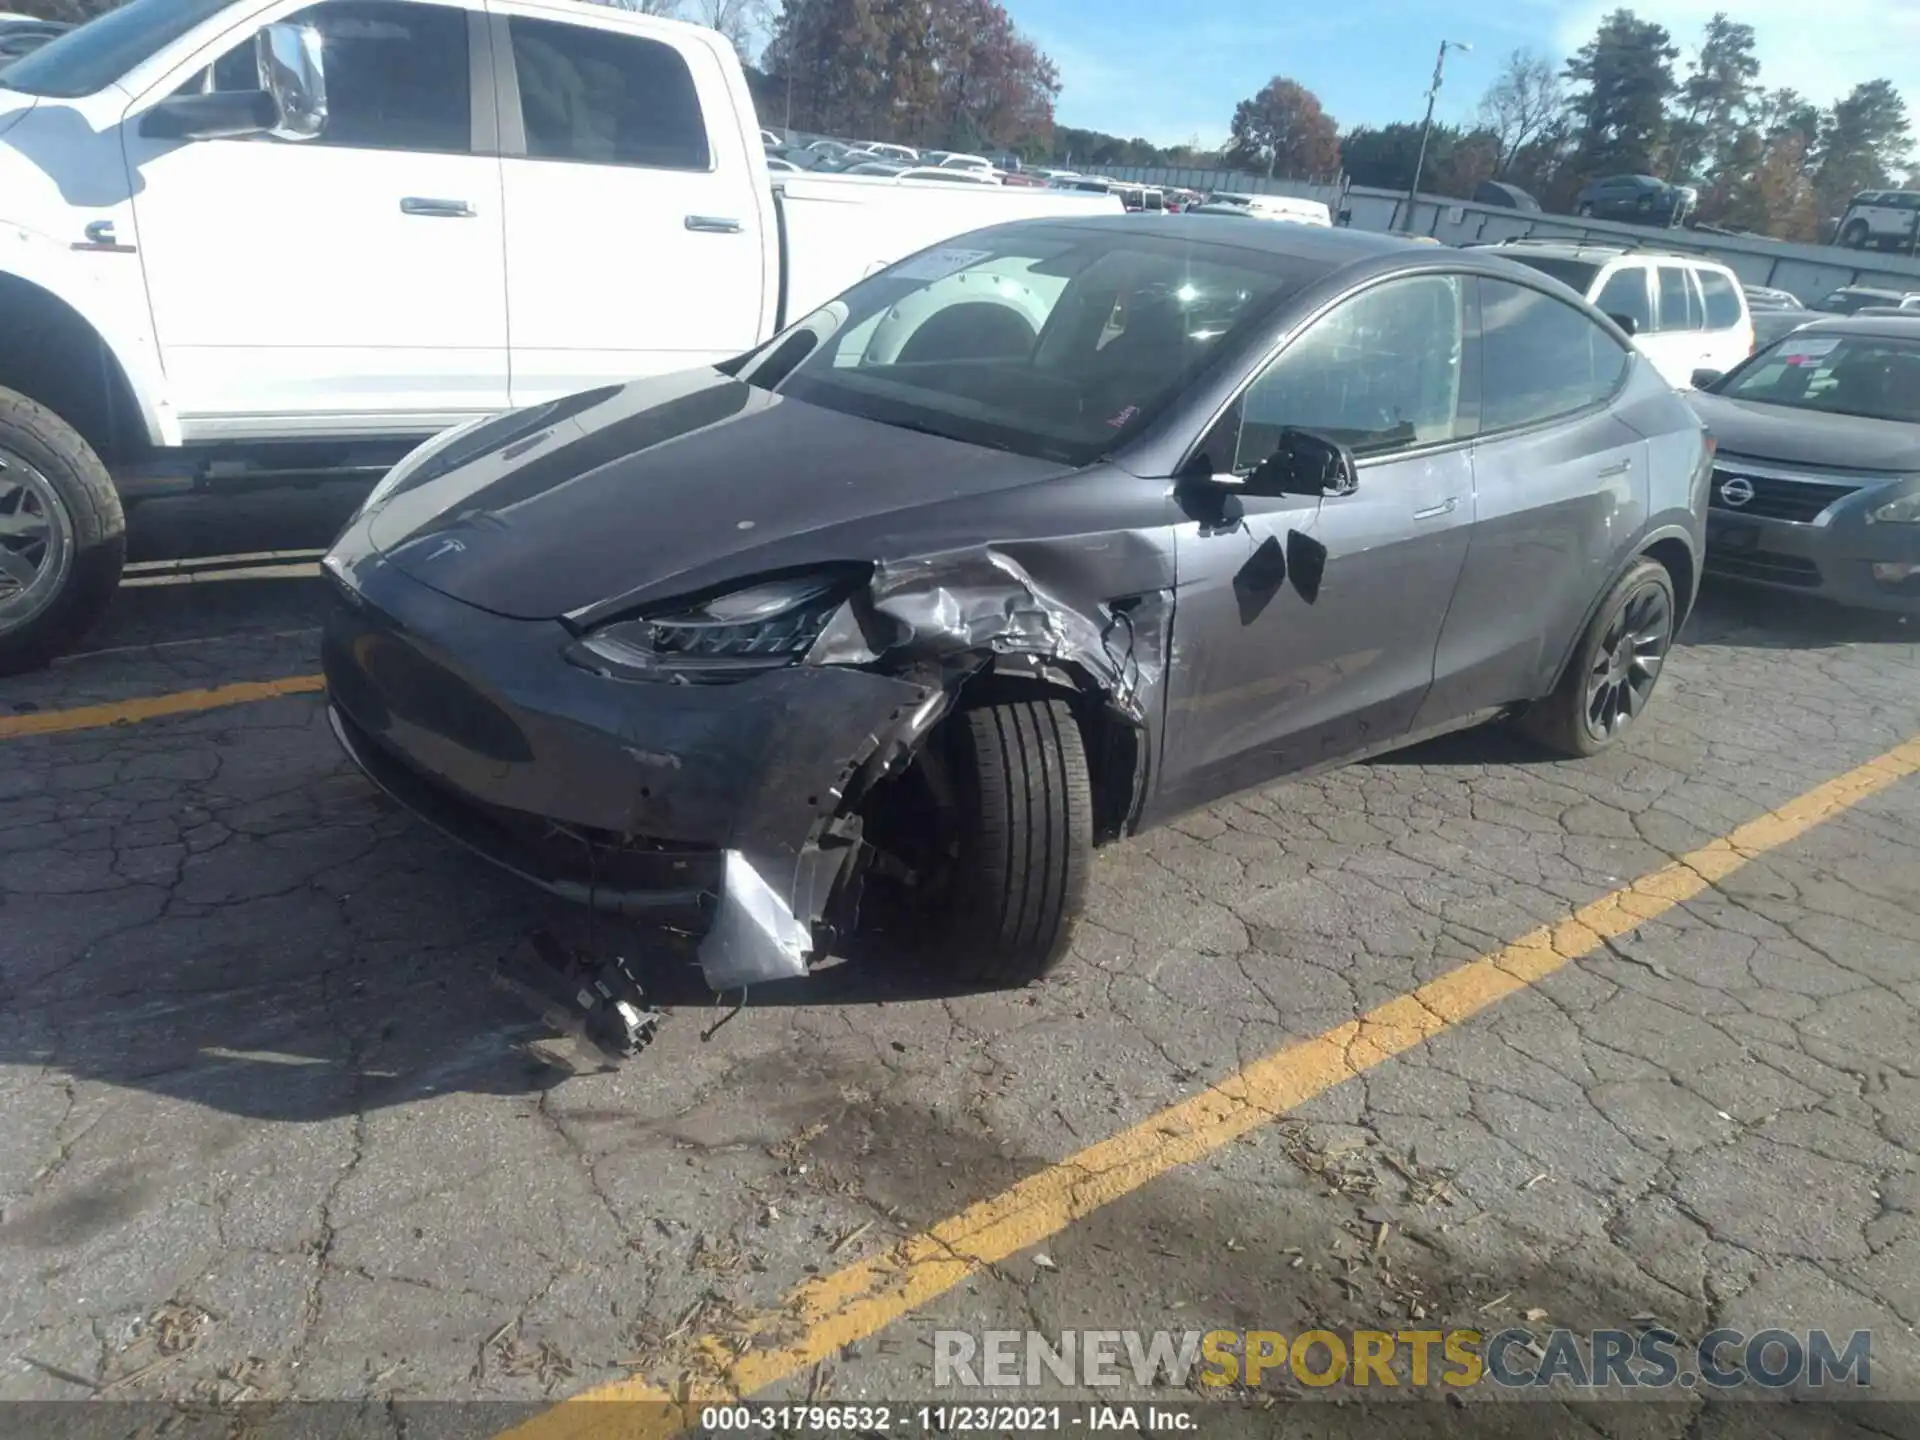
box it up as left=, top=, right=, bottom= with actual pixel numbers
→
left=1235, top=275, right=1465, bottom=470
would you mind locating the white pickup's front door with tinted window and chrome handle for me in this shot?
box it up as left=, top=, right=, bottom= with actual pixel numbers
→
left=123, top=0, right=507, bottom=440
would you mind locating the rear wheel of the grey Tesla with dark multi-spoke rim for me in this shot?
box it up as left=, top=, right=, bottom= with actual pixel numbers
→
left=1521, top=559, right=1676, bottom=756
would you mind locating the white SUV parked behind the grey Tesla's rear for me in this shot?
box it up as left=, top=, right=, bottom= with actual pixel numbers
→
left=1494, top=240, right=1753, bottom=390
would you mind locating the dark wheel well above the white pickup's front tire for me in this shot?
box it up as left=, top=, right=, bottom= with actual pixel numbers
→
left=0, top=275, right=150, bottom=463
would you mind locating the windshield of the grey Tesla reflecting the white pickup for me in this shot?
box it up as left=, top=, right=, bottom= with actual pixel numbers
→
left=778, top=227, right=1319, bottom=465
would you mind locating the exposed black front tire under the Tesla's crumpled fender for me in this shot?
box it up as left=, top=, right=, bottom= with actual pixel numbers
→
left=941, top=699, right=1092, bottom=989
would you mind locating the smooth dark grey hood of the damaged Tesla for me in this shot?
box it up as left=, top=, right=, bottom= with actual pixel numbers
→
left=367, top=371, right=1062, bottom=618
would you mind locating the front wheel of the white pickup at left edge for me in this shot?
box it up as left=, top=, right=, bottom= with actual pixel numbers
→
left=0, top=390, right=127, bottom=676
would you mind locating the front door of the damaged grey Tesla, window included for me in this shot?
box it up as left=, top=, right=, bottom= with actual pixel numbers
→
left=1156, top=275, right=1473, bottom=814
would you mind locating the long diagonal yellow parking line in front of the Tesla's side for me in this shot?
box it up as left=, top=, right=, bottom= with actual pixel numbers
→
left=499, top=737, right=1920, bottom=1440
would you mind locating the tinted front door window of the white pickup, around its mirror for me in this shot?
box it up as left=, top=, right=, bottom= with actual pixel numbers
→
left=184, top=0, right=472, bottom=156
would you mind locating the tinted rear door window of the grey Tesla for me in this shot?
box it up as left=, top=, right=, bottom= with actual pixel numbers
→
left=1480, top=276, right=1628, bottom=432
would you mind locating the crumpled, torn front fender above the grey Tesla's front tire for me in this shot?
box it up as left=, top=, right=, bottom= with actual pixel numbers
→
left=806, top=545, right=1173, bottom=724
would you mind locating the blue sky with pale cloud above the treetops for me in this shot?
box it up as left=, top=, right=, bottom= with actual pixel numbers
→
left=1004, top=0, right=1920, bottom=146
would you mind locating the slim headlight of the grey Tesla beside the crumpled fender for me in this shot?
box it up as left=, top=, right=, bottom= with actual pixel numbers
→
left=566, top=572, right=858, bottom=682
